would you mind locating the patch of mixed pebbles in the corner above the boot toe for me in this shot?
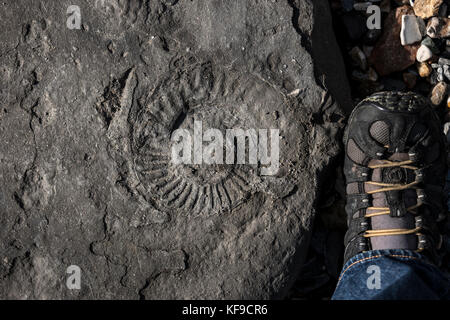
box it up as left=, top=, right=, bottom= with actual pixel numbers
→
left=332, top=0, right=450, bottom=112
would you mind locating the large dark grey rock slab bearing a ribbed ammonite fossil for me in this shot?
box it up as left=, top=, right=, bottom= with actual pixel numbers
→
left=0, top=0, right=348, bottom=299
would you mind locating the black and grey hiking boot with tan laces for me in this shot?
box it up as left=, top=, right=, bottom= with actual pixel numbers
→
left=344, top=92, right=447, bottom=262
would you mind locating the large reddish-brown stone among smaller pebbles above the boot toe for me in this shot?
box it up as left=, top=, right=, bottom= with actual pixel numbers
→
left=369, top=6, right=419, bottom=76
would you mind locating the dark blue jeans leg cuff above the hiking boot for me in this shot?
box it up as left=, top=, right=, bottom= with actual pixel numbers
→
left=332, top=250, right=450, bottom=300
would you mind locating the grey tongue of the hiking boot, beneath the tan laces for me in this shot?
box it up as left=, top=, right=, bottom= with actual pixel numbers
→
left=365, top=153, right=417, bottom=250
